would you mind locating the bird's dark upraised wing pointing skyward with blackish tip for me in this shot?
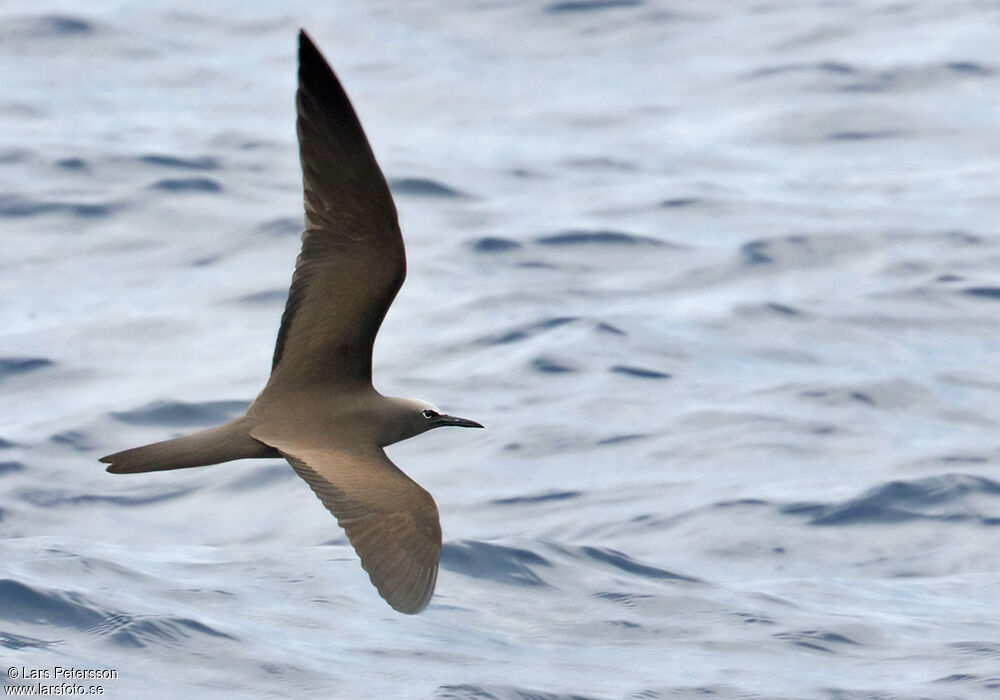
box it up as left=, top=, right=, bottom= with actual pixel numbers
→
left=269, top=31, right=406, bottom=388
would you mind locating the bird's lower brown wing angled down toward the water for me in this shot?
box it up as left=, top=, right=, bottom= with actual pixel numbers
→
left=264, top=438, right=441, bottom=615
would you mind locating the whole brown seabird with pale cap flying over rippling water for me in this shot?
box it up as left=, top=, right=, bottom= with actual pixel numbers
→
left=101, top=30, right=483, bottom=614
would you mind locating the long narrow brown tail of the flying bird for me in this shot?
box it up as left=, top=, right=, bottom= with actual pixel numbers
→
left=101, top=416, right=280, bottom=474
